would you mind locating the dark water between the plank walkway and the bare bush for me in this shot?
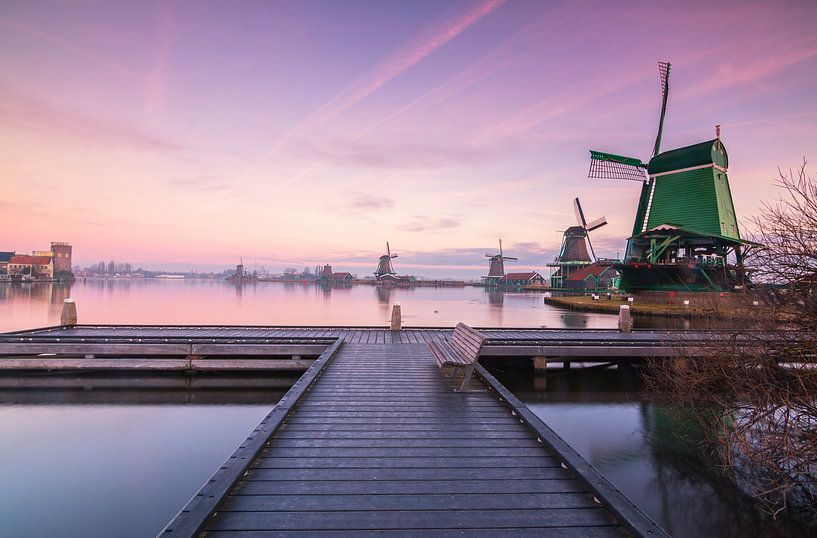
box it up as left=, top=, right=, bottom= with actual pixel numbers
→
left=499, top=369, right=817, bottom=537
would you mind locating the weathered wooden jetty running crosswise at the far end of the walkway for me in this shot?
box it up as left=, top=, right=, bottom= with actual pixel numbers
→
left=0, top=325, right=711, bottom=373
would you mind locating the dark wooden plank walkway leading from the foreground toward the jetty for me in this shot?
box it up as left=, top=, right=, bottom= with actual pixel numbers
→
left=164, top=343, right=663, bottom=536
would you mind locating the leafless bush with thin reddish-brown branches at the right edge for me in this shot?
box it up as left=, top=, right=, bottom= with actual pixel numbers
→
left=647, top=162, right=817, bottom=514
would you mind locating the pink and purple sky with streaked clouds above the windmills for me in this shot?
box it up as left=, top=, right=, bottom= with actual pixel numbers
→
left=0, top=0, right=817, bottom=276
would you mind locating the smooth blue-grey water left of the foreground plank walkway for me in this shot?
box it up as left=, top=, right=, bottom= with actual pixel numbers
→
left=0, top=404, right=272, bottom=537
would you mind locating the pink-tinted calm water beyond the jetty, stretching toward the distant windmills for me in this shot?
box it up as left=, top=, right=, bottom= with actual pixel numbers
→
left=0, top=279, right=616, bottom=331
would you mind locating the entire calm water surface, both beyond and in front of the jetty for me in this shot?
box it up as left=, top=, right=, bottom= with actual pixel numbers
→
left=0, top=280, right=809, bottom=537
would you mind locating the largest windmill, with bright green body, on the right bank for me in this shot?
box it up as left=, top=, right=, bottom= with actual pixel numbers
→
left=588, top=62, right=758, bottom=291
